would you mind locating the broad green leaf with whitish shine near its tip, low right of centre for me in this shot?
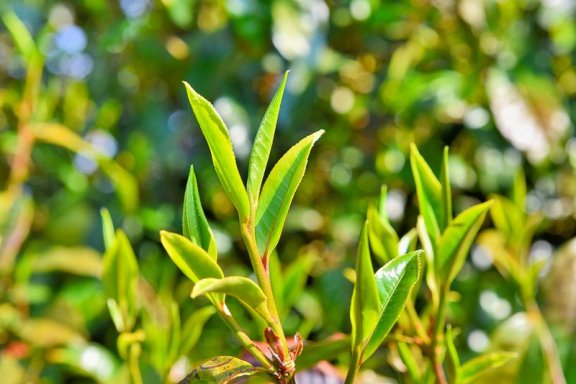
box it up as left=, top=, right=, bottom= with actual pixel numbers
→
left=362, top=251, right=423, bottom=362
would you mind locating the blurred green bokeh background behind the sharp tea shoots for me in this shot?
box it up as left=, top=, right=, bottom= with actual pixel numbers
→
left=0, top=0, right=576, bottom=383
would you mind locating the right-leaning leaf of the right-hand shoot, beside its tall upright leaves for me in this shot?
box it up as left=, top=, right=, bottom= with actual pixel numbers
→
left=435, top=201, right=492, bottom=284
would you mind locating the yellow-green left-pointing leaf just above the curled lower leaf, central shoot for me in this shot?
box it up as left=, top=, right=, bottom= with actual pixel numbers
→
left=160, top=231, right=224, bottom=283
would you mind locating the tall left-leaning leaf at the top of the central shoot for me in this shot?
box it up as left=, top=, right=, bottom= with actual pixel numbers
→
left=184, top=82, right=250, bottom=220
